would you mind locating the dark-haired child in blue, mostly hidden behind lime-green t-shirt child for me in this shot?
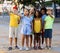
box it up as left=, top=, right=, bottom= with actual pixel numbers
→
left=41, top=7, right=46, bottom=45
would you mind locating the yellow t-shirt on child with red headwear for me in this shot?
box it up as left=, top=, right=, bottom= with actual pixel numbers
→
left=9, top=13, right=20, bottom=27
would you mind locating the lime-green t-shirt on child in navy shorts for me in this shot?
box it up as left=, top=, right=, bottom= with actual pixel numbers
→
left=44, top=15, right=54, bottom=29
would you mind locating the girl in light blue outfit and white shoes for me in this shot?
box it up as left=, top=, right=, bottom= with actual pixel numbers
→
left=20, top=8, right=32, bottom=50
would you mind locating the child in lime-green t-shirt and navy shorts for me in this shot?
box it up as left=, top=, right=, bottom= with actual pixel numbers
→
left=44, top=9, right=54, bottom=49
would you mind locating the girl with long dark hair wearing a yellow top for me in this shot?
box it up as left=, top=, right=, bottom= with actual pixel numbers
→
left=33, top=10, right=42, bottom=49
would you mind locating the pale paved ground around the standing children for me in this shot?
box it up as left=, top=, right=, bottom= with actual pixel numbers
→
left=0, top=23, right=60, bottom=53
